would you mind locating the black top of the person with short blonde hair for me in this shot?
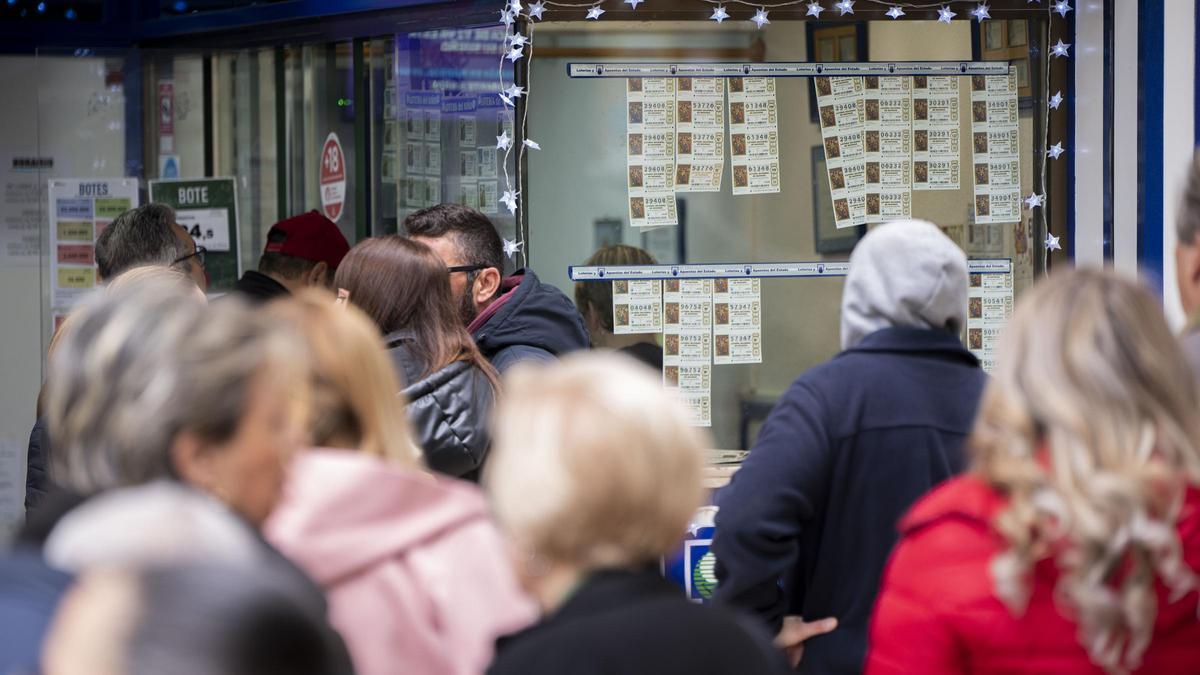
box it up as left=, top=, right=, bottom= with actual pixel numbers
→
left=487, top=571, right=787, bottom=675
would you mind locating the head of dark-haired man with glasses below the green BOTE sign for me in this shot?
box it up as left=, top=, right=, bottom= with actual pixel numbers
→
left=96, top=204, right=191, bottom=280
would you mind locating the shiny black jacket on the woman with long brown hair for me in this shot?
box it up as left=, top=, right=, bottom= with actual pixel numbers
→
left=385, top=330, right=496, bottom=480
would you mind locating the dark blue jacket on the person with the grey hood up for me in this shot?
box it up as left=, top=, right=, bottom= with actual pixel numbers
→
left=713, top=328, right=986, bottom=673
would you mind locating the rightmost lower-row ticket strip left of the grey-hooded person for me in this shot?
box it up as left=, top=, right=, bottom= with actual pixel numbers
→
left=713, top=279, right=762, bottom=365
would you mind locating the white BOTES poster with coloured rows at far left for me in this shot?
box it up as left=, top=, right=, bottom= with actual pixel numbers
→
left=47, top=178, right=138, bottom=311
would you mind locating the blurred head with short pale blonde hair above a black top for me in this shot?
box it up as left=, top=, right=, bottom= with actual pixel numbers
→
left=485, top=352, right=706, bottom=568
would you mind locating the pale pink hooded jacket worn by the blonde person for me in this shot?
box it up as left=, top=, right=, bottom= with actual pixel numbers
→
left=265, top=449, right=536, bottom=675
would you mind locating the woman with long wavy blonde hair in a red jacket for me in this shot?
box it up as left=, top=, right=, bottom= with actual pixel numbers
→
left=866, top=271, right=1200, bottom=675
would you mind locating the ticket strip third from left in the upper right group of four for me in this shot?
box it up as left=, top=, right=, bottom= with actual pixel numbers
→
left=912, top=76, right=960, bottom=190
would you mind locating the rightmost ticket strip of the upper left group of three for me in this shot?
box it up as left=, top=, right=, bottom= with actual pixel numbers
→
left=725, top=77, right=780, bottom=195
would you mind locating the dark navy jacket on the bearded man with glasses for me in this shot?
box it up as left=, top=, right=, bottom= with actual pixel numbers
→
left=472, top=269, right=590, bottom=372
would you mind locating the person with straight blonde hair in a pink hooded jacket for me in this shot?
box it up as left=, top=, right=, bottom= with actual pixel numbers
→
left=272, top=292, right=536, bottom=675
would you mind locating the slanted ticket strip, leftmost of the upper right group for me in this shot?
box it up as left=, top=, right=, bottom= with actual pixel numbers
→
left=812, top=77, right=866, bottom=227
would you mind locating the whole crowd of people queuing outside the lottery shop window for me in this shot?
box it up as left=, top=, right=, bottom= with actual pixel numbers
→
left=7, top=153, right=1200, bottom=675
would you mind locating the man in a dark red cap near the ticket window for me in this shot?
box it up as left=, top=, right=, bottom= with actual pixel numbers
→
left=233, top=210, right=350, bottom=303
